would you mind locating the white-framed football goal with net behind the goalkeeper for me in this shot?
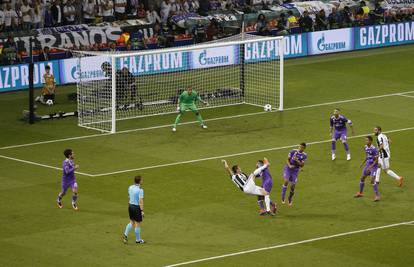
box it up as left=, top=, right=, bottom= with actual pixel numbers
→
left=72, top=33, right=284, bottom=133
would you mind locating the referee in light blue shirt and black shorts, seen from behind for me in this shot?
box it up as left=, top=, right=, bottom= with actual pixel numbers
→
left=122, top=175, right=144, bottom=244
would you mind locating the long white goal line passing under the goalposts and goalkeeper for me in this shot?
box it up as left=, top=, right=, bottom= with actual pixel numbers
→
left=0, top=91, right=414, bottom=150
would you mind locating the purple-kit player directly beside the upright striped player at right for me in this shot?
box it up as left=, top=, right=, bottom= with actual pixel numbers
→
left=354, top=136, right=380, bottom=201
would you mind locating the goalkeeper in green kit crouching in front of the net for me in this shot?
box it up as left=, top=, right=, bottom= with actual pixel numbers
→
left=173, top=86, right=208, bottom=132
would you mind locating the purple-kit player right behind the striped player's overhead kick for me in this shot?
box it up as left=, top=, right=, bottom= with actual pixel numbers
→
left=256, top=160, right=276, bottom=215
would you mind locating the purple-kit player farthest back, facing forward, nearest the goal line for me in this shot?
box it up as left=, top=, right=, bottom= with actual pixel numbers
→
left=329, top=108, right=354, bottom=160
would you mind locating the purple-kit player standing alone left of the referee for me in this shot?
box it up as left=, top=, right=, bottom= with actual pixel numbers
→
left=57, top=149, right=79, bottom=210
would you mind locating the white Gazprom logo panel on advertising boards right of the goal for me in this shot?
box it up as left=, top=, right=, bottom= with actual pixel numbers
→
left=308, top=28, right=354, bottom=55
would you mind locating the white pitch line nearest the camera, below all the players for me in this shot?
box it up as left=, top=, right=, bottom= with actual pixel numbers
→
left=165, top=221, right=414, bottom=267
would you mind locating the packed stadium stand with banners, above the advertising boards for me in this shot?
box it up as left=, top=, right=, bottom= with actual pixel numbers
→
left=0, top=0, right=414, bottom=65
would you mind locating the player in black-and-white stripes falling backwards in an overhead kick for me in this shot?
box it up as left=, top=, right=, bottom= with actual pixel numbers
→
left=222, top=158, right=275, bottom=215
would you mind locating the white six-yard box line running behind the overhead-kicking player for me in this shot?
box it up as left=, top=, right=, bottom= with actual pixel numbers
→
left=92, top=127, right=414, bottom=177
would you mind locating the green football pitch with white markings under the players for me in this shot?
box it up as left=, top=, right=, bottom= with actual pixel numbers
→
left=0, top=45, right=414, bottom=266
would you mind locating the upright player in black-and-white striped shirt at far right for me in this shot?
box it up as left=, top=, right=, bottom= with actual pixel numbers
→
left=374, top=126, right=404, bottom=187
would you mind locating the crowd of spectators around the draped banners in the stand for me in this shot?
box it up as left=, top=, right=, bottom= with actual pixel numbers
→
left=0, top=0, right=414, bottom=65
